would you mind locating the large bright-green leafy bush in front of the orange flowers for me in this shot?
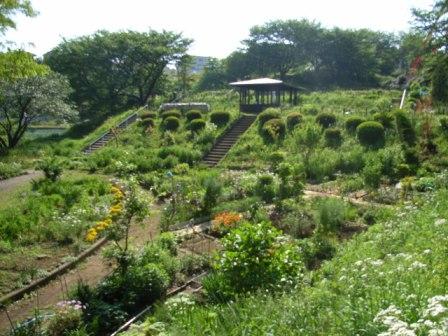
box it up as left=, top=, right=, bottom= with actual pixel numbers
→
left=204, top=222, right=303, bottom=301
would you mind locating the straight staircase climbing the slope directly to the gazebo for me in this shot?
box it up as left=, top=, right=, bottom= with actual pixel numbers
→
left=202, top=115, right=257, bottom=167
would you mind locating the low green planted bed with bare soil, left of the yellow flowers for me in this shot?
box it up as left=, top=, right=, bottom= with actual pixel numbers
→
left=0, top=173, right=113, bottom=293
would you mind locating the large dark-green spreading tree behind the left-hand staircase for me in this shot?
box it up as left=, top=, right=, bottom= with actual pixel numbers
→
left=44, top=30, right=191, bottom=119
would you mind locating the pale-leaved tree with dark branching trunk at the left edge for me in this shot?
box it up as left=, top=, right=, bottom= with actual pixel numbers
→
left=0, top=74, right=76, bottom=151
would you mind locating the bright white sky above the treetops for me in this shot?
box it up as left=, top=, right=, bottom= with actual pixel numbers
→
left=5, top=0, right=433, bottom=58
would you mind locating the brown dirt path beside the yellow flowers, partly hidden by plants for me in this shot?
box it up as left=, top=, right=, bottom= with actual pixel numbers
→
left=0, top=206, right=160, bottom=333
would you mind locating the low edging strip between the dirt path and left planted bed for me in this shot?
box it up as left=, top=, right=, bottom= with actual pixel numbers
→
left=0, top=237, right=107, bottom=306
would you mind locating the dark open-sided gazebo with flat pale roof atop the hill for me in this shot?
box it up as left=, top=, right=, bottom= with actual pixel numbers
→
left=230, top=78, right=299, bottom=112
